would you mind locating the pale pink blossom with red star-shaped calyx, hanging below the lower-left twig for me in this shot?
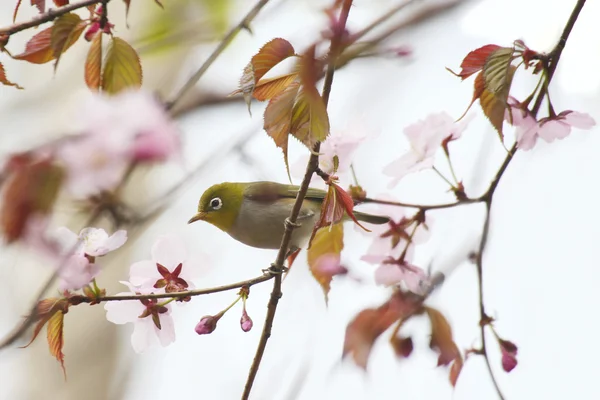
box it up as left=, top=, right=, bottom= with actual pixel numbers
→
left=104, top=281, right=175, bottom=353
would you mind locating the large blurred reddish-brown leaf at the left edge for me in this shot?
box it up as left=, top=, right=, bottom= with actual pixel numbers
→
left=0, top=154, right=64, bottom=243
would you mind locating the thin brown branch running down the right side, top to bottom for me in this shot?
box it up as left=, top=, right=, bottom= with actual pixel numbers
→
left=476, top=0, right=585, bottom=399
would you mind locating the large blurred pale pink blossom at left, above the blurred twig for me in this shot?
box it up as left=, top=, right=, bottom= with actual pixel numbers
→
left=59, top=91, right=180, bottom=198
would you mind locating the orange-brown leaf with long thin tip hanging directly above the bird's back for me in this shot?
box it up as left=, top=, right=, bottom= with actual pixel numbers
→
left=263, top=82, right=300, bottom=176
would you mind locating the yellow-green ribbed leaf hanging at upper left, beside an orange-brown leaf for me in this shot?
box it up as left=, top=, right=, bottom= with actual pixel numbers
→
left=102, top=37, right=142, bottom=94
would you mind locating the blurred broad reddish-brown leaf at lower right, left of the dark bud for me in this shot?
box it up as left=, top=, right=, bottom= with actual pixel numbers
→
left=342, top=292, right=421, bottom=369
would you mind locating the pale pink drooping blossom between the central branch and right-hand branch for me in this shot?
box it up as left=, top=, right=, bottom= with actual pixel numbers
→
left=383, top=112, right=469, bottom=188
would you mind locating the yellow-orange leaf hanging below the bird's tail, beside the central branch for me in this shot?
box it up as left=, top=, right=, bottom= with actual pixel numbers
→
left=307, top=224, right=344, bottom=303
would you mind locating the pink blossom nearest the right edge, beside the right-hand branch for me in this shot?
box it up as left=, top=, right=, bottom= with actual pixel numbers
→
left=506, top=97, right=596, bottom=151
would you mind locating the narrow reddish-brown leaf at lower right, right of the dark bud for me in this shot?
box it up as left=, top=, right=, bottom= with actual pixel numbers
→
left=425, top=307, right=463, bottom=386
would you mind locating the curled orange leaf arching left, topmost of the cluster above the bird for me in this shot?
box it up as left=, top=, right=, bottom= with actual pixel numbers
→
left=236, top=38, right=295, bottom=111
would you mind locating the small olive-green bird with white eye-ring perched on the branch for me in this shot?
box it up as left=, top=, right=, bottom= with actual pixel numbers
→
left=188, top=181, right=389, bottom=249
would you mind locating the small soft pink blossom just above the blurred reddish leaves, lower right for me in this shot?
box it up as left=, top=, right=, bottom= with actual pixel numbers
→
left=375, top=262, right=429, bottom=294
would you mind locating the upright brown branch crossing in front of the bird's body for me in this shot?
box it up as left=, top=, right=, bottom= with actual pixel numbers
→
left=242, top=0, right=352, bottom=400
